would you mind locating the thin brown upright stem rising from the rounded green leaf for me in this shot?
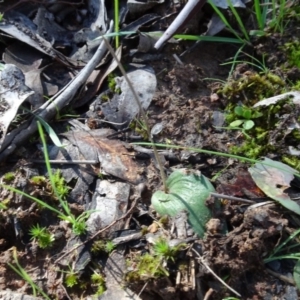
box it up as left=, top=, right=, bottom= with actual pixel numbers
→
left=103, top=37, right=168, bottom=193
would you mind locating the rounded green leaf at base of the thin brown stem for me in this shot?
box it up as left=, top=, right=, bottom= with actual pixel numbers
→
left=151, top=169, right=215, bottom=237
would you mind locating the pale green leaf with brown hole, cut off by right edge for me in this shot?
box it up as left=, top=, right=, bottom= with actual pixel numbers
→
left=248, top=158, right=300, bottom=215
